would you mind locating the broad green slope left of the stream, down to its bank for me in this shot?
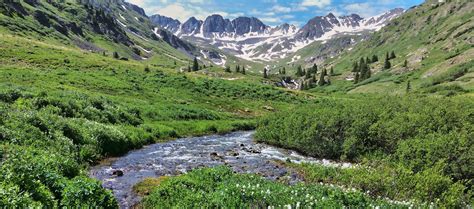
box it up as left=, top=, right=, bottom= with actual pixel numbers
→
left=0, top=7, right=308, bottom=208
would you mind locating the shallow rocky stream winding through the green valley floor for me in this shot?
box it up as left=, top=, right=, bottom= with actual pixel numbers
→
left=90, top=132, right=350, bottom=208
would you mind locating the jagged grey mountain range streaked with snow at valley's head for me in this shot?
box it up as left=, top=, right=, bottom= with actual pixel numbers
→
left=150, top=8, right=404, bottom=62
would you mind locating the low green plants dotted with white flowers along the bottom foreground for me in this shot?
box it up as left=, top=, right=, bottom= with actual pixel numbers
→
left=143, top=167, right=401, bottom=208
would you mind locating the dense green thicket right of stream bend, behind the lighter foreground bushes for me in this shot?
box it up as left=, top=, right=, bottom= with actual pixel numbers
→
left=255, top=97, right=474, bottom=160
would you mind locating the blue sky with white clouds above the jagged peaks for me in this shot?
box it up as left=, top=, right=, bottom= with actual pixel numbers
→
left=127, top=0, right=423, bottom=26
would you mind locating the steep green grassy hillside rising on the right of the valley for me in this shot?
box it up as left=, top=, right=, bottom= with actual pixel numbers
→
left=326, top=1, right=474, bottom=95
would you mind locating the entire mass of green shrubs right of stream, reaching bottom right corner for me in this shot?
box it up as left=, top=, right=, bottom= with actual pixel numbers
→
left=255, top=97, right=474, bottom=207
